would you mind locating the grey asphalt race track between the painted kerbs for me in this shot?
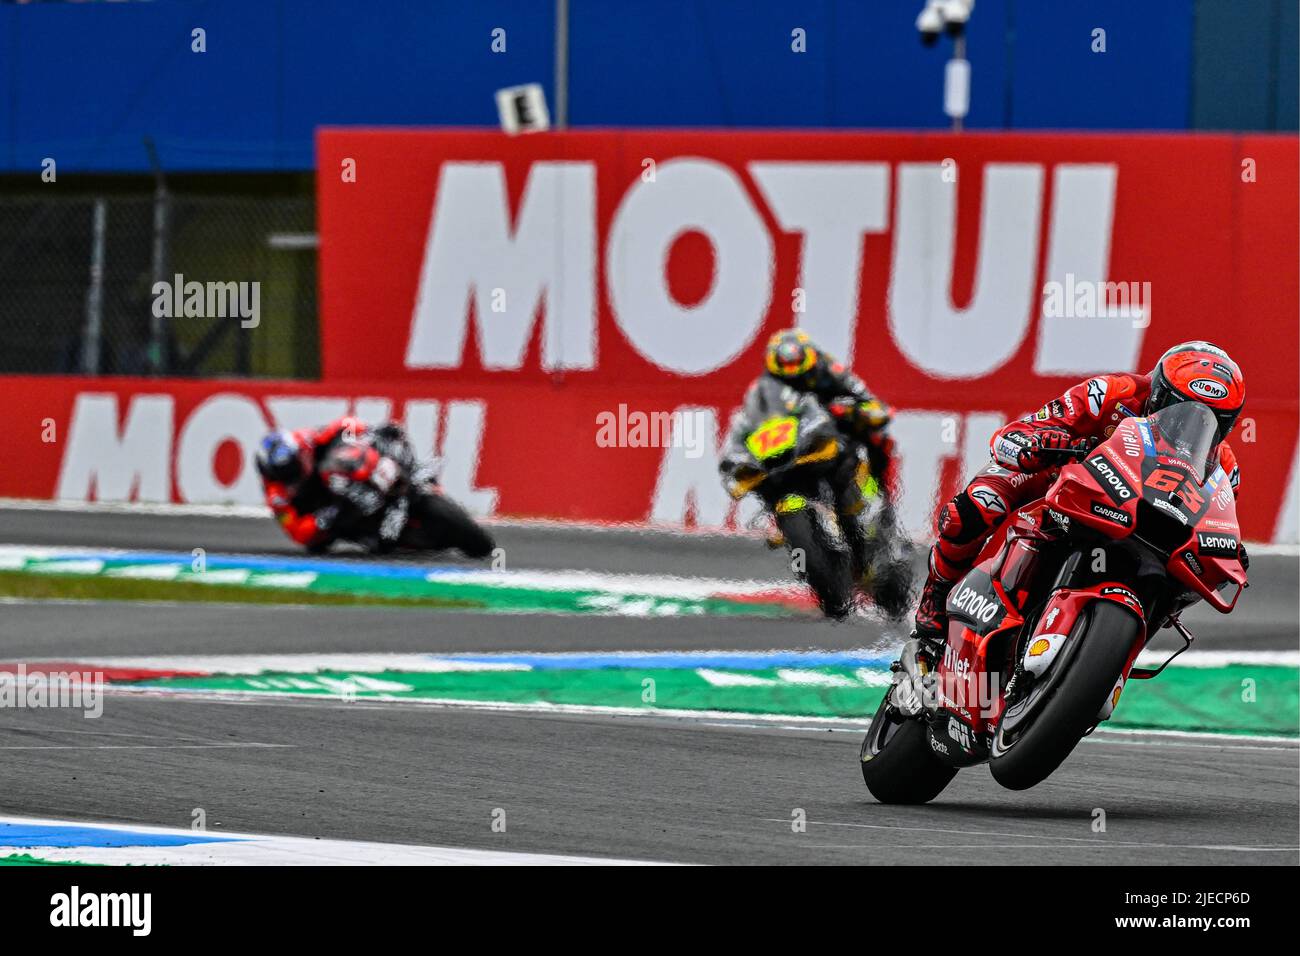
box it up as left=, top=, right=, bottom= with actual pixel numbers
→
left=0, top=510, right=1300, bottom=865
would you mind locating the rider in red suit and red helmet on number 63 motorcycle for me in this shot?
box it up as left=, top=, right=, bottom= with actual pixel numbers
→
left=905, top=342, right=1247, bottom=671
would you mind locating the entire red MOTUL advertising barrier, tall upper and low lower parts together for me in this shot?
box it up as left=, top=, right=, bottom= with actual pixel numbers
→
left=0, top=130, right=1300, bottom=540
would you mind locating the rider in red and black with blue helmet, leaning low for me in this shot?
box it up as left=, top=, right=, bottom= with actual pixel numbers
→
left=248, top=416, right=413, bottom=551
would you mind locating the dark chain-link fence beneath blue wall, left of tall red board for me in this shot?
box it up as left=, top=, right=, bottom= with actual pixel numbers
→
left=0, top=194, right=320, bottom=377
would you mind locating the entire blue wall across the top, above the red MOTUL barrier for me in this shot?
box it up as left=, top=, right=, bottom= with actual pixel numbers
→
left=0, top=0, right=1296, bottom=172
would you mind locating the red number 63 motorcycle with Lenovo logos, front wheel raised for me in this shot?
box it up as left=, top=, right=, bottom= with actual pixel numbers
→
left=862, top=402, right=1247, bottom=804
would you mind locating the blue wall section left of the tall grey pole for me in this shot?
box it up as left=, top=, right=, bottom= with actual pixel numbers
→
left=0, top=0, right=554, bottom=170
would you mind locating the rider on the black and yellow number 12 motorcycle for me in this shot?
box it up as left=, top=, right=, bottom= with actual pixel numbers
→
left=723, top=329, right=894, bottom=554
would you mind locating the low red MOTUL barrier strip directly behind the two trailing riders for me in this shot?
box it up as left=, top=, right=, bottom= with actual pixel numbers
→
left=0, top=366, right=1295, bottom=541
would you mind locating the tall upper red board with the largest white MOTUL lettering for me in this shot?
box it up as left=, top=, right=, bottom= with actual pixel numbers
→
left=319, top=129, right=1300, bottom=537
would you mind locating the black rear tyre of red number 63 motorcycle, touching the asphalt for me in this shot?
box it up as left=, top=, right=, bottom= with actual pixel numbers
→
left=859, top=696, right=957, bottom=804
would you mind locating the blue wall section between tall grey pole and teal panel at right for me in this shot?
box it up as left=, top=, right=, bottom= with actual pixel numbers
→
left=571, top=0, right=1196, bottom=129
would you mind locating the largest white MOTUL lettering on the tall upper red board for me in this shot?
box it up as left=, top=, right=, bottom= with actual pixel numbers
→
left=403, top=157, right=1143, bottom=378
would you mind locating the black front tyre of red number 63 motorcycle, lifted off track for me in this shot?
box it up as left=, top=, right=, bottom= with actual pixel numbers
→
left=988, top=601, right=1141, bottom=790
